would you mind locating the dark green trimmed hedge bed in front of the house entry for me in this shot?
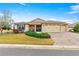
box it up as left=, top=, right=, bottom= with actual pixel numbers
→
left=25, top=31, right=50, bottom=38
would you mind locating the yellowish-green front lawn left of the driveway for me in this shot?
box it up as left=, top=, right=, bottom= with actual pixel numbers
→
left=0, top=34, right=54, bottom=45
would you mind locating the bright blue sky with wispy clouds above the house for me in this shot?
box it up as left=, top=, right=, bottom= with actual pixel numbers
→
left=0, top=3, right=79, bottom=23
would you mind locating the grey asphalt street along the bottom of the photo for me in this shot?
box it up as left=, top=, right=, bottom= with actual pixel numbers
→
left=0, top=48, right=79, bottom=56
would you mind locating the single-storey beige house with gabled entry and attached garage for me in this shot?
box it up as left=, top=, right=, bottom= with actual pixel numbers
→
left=15, top=18, right=69, bottom=32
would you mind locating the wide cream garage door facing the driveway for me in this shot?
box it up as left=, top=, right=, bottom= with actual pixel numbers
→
left=43, top=25, right=66, bottom=32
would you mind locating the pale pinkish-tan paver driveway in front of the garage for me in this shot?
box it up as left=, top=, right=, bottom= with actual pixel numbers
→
left=49, top=32, right=79, bottom=45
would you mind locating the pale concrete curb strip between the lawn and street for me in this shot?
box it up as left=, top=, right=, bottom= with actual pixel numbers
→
left=0, top=44, right=79, bottom=50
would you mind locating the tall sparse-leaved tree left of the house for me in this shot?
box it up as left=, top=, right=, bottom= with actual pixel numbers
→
left=0, top=10, right=13, bottom=29
